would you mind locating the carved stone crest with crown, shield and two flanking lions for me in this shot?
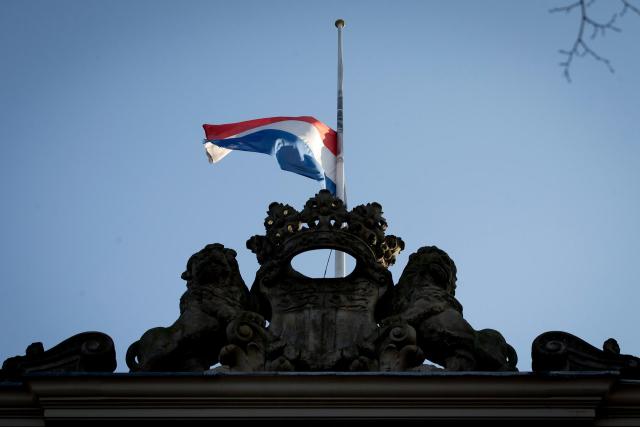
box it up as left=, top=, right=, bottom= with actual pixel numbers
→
left=126, top=190, right=517, bottom=372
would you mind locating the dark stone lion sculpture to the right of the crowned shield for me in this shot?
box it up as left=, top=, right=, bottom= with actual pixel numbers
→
left=393, top=246, right=518, bottom=371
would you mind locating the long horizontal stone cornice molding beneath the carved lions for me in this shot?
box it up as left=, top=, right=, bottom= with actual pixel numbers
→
left=0, top=372, right=640, bottom=426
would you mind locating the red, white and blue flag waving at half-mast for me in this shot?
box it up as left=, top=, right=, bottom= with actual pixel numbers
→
left=202, top=116, right=337, bottom=194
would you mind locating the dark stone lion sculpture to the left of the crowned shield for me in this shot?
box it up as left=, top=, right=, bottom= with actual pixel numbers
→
left=126, top=243, right=252, bottom=371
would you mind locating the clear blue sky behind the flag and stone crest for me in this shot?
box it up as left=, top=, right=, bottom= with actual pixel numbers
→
left=0, top=0, right=640, bottom=372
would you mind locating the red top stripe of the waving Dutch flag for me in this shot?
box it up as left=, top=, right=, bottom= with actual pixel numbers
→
left=202, top=116, right=338, bottom=156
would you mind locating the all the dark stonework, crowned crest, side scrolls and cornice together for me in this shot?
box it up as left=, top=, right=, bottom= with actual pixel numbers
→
left=0, top=191, right=640, bottom=426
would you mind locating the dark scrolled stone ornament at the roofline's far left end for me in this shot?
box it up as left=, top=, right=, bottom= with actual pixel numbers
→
left=0, top=332, right=116, bottom=379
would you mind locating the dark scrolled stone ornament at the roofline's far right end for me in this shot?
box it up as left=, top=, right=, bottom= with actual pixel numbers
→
left=531, top=331, right=640, bottom=379
